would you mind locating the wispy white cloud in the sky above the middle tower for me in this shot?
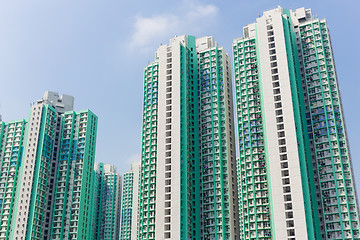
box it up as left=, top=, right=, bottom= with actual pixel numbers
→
left=129, top=0, right=218, bottom=50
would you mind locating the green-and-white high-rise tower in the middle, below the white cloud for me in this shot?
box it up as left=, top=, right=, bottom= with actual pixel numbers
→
left=138, top=36, right=239, bottom=239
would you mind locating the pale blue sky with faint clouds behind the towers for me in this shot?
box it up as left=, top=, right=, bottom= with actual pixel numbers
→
left=0, top=0, right=360, bottom=186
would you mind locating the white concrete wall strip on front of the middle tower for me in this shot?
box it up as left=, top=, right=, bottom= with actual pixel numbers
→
left=155, top=36, right=187, bottom=239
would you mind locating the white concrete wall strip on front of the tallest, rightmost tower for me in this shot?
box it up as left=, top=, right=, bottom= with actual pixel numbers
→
left=257, top=9, right=307, bottom=239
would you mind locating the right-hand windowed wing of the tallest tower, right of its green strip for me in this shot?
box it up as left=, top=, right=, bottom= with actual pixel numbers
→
left=297, top=9, right=360, bottom=239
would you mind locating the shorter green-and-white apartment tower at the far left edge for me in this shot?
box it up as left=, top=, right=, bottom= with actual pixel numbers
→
left=0, top=92, right=97, bottom=240
